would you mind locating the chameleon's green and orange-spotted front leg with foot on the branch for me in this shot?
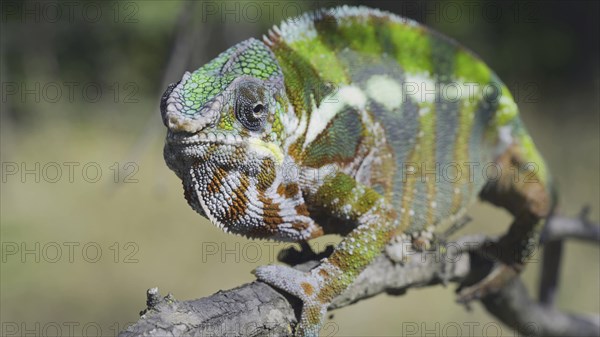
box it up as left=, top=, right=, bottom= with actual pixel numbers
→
left=254, top=174, right=397, bottom=336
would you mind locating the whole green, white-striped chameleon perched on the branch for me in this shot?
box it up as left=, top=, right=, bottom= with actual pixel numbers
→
left=161, top=6, right=556, bottom=336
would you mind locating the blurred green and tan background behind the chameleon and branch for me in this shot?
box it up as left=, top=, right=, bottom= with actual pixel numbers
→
left=0, top=1, right=600, bottom=336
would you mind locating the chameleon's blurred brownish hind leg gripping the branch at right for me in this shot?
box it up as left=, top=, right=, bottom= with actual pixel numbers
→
left=459, top=133, right=555, bottom=302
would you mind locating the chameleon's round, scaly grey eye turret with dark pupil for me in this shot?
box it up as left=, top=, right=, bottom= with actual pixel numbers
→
left=235, top=81, right=267, bottom=131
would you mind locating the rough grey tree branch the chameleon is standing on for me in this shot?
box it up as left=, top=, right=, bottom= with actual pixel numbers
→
left=119, top=217, right=600, bottom=337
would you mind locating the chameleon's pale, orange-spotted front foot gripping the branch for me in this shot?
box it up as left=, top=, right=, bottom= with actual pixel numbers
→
left=253, top=265, right=329, bottom=337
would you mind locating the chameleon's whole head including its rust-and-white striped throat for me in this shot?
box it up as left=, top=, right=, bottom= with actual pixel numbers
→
left=161, top=39, right=318, bottom=239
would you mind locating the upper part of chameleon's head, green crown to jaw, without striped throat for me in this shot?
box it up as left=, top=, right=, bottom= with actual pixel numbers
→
left=161, top=39, right=286, bottom=177
